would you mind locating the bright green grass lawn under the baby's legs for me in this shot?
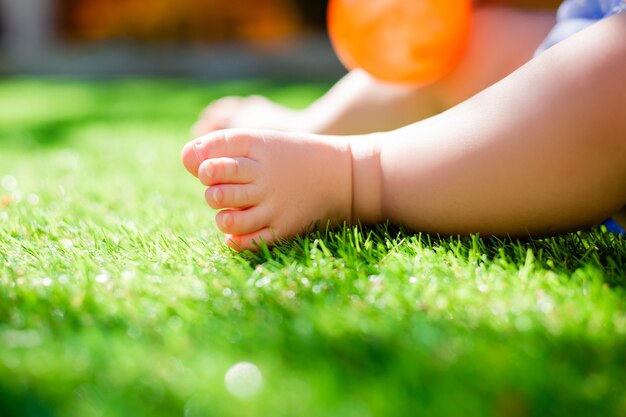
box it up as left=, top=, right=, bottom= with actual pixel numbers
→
left=0, top=79, right=626, bottom=417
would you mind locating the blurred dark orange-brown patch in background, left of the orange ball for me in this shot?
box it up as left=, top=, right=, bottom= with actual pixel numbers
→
left=56, top=0, right=310, bottom=42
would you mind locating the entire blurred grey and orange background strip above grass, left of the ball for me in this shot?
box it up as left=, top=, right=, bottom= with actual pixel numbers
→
left=0, top=0, right=344, bottom=80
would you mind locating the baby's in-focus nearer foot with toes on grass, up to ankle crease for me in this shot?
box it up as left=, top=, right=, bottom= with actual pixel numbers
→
left=182, top=130, right=352, bottom=250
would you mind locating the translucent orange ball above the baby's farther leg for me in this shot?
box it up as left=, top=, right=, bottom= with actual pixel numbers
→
left=328, top=0, right=472, bottom=84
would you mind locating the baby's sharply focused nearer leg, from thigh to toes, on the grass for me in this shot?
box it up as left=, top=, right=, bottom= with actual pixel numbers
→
left=183, top=13, right=626, bottom=249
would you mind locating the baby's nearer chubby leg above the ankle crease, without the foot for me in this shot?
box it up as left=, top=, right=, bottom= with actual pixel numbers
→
left=354, top=13, right=626, bottom=236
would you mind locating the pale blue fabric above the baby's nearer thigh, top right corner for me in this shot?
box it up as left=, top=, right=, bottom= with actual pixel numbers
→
left=535, top=0, right=626, bottom=55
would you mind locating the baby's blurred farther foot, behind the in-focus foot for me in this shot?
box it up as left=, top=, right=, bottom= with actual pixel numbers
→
left=192, top=96, right=300, bottom=137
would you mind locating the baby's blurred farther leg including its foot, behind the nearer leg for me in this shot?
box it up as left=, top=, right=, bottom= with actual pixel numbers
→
left=194, top=6, right=554, bottom=136
